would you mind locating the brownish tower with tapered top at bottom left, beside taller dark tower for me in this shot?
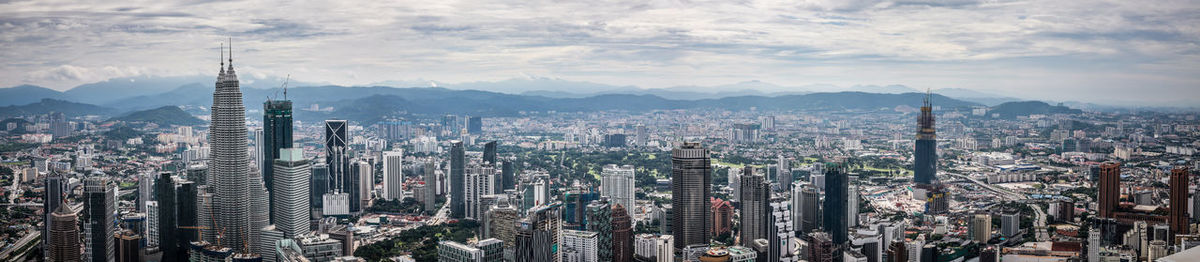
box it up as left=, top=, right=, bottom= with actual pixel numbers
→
left=46, top=204, right=82, bottom=262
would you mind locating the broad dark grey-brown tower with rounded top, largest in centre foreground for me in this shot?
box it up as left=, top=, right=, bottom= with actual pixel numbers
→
left=671, top=142, right=713, bottom=250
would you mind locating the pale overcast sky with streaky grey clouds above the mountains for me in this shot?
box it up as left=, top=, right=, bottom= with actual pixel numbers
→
left=0, top=0, right=1200, bottom=105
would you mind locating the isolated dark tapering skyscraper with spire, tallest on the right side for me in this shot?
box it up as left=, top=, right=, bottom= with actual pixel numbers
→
left=912, top=94, right=937, bottom=185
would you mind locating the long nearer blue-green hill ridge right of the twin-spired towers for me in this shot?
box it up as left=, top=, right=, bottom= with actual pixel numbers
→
left=304, top=88, right=980, bottom=123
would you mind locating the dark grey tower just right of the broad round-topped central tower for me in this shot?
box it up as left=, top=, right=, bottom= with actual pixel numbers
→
left=738, top=166, right=770, bottom=245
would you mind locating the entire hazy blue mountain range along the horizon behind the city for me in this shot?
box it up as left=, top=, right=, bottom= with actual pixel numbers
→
left=0, top=77, right=1089, bottom=123
